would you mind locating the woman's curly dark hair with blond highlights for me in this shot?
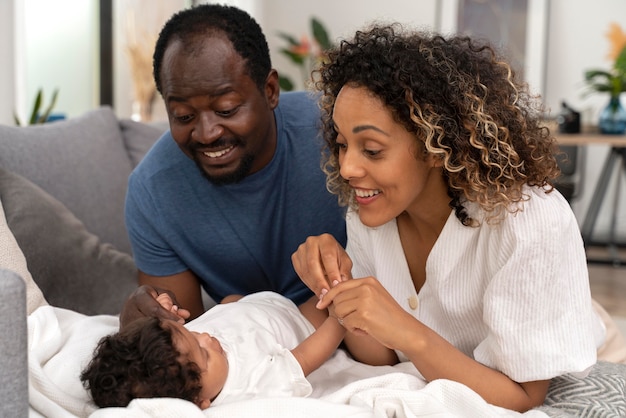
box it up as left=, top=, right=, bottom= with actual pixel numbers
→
left=315, top=24, right=559, bottom=225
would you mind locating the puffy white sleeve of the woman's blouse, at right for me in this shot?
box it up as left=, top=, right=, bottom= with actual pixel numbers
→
left=474, top=194, right=596, bottom=382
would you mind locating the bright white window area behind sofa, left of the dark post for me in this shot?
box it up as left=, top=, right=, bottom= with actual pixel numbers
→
left=12, top=0, right=99, bottom=120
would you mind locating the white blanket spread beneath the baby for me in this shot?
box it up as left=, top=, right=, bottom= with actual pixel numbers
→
left=28, top=306, right=547, bottom=418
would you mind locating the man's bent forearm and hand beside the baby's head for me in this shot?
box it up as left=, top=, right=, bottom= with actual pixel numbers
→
left=120, top=270, right=204, bottom=329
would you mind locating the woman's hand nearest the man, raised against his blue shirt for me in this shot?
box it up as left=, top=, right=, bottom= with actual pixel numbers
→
left=291, top=234, right=352, bottom=297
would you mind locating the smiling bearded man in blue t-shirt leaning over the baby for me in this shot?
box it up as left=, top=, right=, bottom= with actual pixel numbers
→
left=120, top=4, right=345, bottom=327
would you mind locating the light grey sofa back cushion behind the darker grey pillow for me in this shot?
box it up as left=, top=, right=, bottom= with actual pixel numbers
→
left=0, top=107, right=132, bottom=252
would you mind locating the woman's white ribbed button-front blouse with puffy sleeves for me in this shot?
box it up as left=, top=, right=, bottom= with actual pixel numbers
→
left=347, top=187, right=604, bottom=382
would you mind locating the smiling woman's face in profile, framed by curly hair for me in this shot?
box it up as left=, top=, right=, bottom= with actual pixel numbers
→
left=333, top=85, right=447, bottom=227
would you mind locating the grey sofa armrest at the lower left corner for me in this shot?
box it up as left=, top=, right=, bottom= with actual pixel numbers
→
left=0, top=268, right=28, bottom=417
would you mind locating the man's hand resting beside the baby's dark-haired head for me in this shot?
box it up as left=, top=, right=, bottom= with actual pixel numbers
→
left=120, top=285, right=190, bottom=329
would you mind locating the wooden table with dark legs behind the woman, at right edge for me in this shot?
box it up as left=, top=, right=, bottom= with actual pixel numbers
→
left=553, top=130, right=626, bottom=265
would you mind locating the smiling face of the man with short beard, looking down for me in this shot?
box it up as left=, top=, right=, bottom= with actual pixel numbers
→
left=161, top=34, right=278, bottom=184
